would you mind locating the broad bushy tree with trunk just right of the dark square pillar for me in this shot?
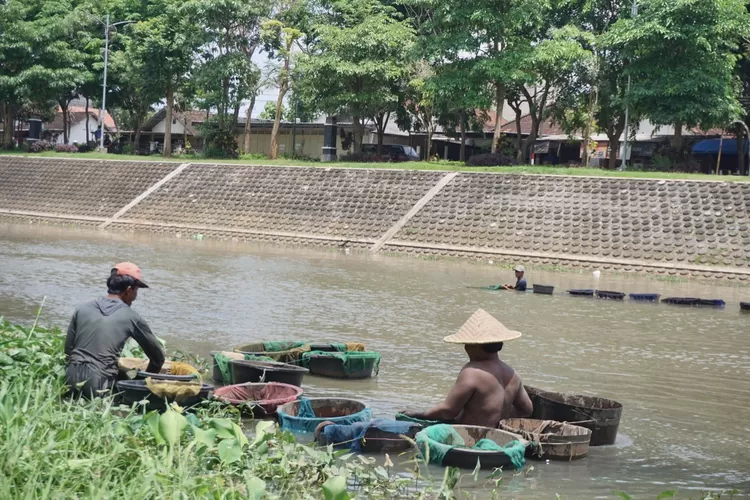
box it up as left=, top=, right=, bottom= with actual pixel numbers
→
left=296, top=0, right=414, bottom=151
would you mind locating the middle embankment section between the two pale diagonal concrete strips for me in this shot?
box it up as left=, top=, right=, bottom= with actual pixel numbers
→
left=119, top=164, right=445, bottom=241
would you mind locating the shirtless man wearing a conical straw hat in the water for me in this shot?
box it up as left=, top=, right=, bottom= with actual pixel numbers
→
left=402, top=309, right=534, bottom=428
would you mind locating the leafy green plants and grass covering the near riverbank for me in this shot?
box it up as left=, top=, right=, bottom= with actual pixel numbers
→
left=0, top=319, right=446, bottom=500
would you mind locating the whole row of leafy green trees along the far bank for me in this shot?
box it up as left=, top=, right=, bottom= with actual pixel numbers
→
left=0, top=0, right=750, bottom=169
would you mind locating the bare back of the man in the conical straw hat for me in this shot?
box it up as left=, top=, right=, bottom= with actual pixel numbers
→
left=458, top=359, right=521, bottom=427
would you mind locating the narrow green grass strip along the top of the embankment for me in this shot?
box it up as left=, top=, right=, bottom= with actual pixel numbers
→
left=0, top=151, right=750, bottom=182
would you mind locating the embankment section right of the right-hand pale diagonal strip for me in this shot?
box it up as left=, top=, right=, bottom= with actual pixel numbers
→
left=389, top=174, right=750, bottom=268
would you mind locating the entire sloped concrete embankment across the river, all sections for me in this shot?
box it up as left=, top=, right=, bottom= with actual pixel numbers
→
left=0, top=156, right=750, bottom=282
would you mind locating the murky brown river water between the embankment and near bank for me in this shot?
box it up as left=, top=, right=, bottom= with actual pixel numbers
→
left=0, top=226, right=750, bottom=498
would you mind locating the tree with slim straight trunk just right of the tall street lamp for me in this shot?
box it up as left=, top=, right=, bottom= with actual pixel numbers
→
left=133, top=0, right=205, bottom=157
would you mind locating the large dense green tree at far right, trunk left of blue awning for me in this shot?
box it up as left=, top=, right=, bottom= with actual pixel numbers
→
left=605, top=0, right=750, bottom=149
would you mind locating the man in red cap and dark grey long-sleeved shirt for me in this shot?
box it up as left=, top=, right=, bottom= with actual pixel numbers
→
left=65, top=262, right=164, bottom=398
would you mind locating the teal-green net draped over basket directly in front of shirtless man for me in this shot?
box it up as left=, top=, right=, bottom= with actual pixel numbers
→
left=416, top=424, right=526, bottom=469
